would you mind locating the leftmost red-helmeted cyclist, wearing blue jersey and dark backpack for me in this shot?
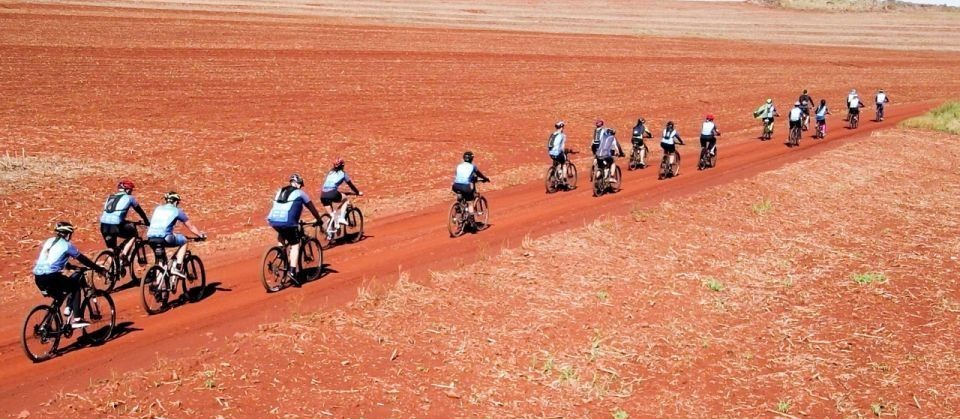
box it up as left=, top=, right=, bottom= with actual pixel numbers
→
left=100, top=179, right=150, bottom=262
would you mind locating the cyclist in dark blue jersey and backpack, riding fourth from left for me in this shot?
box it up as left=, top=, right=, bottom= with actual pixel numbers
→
left=267, top=173, right=320, bottom=285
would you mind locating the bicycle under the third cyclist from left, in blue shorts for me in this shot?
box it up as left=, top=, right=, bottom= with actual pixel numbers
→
left=140, top=237, right=207, bottom=315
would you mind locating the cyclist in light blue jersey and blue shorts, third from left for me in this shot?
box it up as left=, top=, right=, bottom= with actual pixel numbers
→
left=147, top=191, right=207, bottom=278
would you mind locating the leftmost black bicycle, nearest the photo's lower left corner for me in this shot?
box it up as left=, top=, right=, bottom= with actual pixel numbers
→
left=20, top=265, right=117, bottom=362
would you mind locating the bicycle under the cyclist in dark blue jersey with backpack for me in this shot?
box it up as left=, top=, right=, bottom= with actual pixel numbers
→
left=260, top=221, right=324, bottom=292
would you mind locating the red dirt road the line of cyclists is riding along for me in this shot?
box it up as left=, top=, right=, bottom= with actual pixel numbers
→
left=0, top=102, right=933, bottom=414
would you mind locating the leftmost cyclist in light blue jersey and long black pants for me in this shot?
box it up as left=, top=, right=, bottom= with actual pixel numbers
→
left=33, top=221, right=107, bottom=329
